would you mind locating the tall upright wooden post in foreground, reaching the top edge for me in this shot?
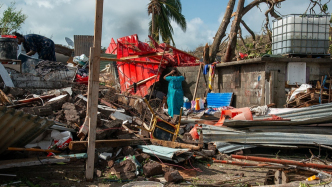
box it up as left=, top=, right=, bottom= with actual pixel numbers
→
left=86, top=0, right=104, bottom=181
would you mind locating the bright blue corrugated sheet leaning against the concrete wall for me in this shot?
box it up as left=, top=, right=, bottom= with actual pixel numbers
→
left=206, top=92, right=233, bottom=108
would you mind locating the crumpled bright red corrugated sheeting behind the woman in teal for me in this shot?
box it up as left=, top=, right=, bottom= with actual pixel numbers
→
left=106, top=34, right=199, bottom=97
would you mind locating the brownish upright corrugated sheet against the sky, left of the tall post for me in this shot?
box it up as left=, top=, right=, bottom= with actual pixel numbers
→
left=74, top=35, right=94, bottom=56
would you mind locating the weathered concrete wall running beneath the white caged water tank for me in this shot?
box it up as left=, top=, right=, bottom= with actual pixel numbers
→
left=161, top=57, right=332, bottom=108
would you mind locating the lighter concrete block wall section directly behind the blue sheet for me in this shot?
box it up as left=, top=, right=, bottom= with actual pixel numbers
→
left=213, top=63, right=265, bottom=108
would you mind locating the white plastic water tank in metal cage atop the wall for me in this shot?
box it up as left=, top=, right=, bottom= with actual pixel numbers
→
left=272, top=14, right=330, bottom=55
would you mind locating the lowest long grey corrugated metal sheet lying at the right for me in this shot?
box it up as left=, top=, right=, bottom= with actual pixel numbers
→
left=202, top=125, right=332, bottom=145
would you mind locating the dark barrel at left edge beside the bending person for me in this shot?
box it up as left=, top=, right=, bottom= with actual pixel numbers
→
left=0, top=38, right=18, bottom=59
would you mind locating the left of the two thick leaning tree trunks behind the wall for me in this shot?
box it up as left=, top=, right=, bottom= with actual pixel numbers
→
left=225, top=0, right=245, bottom=62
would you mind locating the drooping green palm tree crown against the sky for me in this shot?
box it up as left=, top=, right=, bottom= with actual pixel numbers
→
left=148, top=0, right=187, bottom=45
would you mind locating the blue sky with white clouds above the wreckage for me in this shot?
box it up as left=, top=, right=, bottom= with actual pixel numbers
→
left=0, top=0, right=332, bottom=51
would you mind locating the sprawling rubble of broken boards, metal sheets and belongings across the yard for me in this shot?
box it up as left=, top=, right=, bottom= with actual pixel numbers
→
left=0, top=32, right=332, bottom=186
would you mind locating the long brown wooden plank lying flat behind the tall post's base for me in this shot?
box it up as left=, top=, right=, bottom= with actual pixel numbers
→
left=69, top=138, right=151, bottom=151
